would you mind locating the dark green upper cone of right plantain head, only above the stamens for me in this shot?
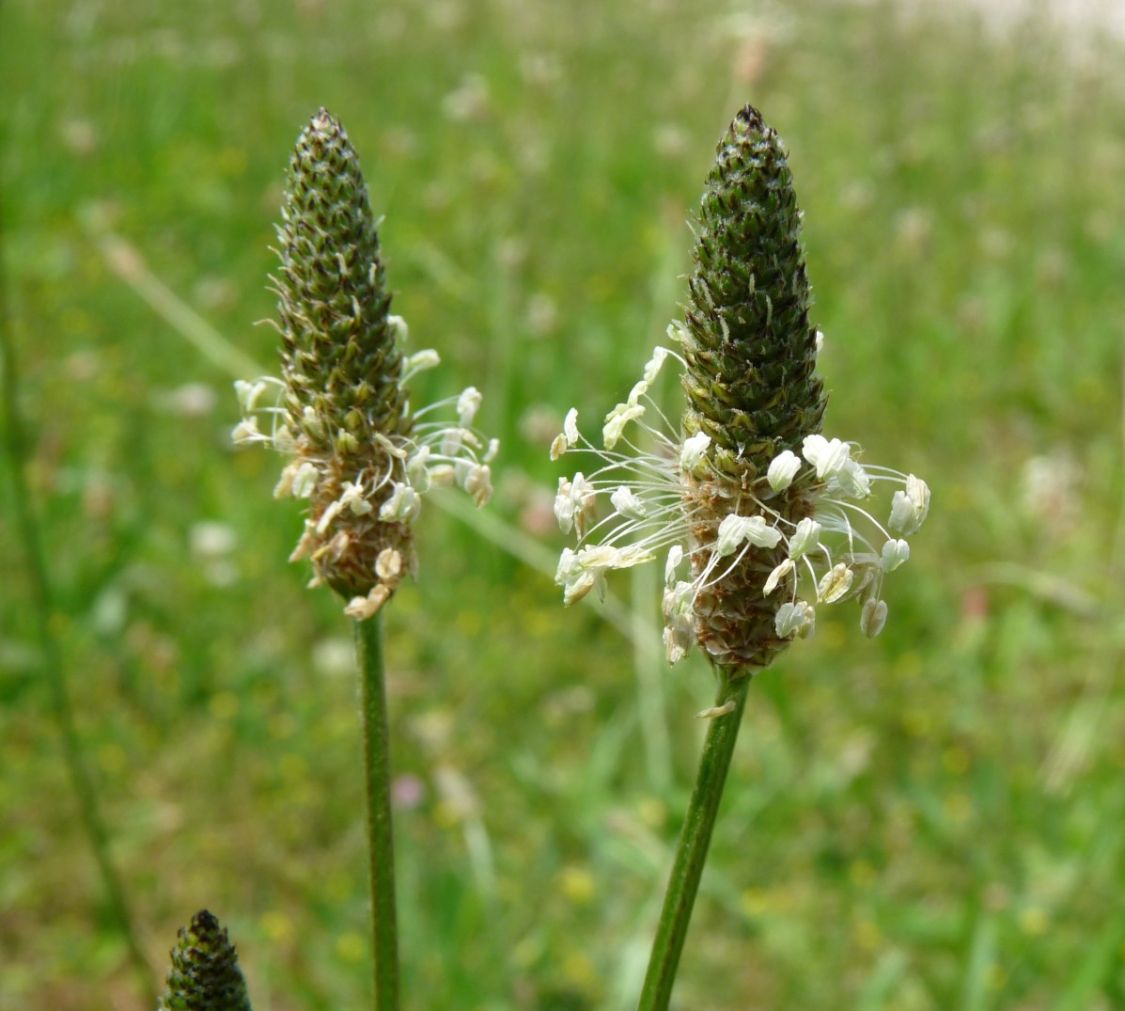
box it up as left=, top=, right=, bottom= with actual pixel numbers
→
left=684, top=106, right=826, bottom=478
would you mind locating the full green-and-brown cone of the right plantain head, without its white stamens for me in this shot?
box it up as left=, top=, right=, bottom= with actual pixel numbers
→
left=683, top=106, right=826, bottom=674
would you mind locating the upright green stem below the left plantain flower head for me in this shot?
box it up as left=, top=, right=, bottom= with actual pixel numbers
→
left=356, top=614, right=398, bottom=1011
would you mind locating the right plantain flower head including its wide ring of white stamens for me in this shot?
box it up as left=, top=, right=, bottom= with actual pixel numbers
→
left=551, top=106, right=929, bottom=676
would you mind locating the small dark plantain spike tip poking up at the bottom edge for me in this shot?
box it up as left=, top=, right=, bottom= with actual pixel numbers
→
left=156, top=910, right=251, bottom=1011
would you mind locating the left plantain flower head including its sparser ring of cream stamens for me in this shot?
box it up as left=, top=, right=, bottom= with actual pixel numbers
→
left=232, top=109, right=497, bottom=620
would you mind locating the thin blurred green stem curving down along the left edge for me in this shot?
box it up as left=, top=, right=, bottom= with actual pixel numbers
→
left=0, top=217, right=156, bottom=1007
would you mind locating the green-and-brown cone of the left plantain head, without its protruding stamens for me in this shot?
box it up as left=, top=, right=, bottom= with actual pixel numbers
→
left=275, top=109, right=414, bottom=599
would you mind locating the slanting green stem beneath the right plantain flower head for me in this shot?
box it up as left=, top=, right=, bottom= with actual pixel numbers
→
left=638, top=671, right=750, bottom=1011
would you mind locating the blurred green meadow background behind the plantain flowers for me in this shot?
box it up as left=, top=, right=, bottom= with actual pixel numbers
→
left=0, top=0, right=1125, bottom=1011
